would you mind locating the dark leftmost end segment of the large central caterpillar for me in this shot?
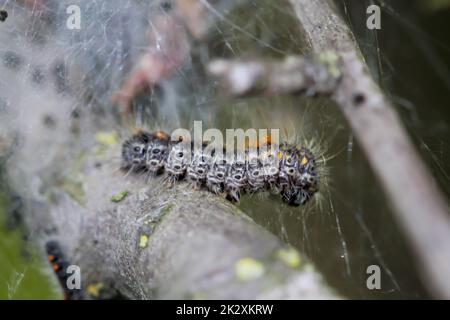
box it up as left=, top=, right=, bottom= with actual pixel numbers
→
left=122, top=132, right=153, bottom=170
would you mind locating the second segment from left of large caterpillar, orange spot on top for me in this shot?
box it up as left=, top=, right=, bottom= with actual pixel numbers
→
left=146, top=132, right=169, bottom=174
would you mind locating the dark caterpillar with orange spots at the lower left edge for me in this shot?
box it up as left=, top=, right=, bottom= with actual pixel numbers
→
left=45, top=241, right=84, bottom=300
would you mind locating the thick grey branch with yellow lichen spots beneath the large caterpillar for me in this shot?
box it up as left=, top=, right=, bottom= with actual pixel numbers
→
left=20, top=141, right=337, bottom=299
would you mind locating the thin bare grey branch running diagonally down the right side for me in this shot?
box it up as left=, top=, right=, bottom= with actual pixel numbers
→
left=289, top=0, right=450, bottom=299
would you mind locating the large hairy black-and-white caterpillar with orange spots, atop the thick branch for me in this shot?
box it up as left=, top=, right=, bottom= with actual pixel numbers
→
left=122, top=131, right=319, bottom=206
